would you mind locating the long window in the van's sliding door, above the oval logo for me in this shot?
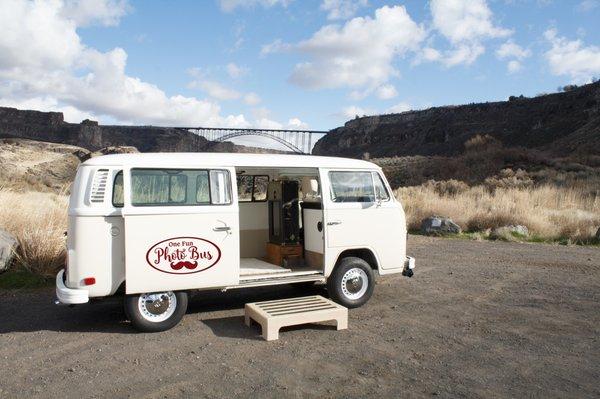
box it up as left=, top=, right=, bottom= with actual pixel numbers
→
left=130, top=169, right=231, bottom=206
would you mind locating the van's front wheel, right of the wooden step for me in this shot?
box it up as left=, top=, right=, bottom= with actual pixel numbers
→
left=327, top=256, right=375, bottom=308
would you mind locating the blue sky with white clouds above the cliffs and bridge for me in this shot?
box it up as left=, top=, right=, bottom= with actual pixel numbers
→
left=0, top=0, right=600, bottom=148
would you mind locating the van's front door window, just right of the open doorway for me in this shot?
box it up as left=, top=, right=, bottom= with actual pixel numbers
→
left=329, top=172, right=375, bottom=202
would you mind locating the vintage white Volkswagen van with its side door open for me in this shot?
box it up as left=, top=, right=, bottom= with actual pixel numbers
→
left=56, top=153, right=415, bottom=331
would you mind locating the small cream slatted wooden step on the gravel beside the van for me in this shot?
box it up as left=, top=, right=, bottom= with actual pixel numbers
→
left=244, top=295, right=348, bottom=341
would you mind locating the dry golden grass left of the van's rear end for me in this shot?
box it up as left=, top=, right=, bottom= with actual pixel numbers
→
left=0, top=189, right=68, bottom=276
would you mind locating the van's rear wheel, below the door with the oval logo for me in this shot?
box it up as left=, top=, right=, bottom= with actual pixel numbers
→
left=125, top=291, right=188, bottom=332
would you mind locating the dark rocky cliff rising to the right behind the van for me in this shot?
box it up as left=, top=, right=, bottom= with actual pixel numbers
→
left=313, top=82, right=600, bottom=158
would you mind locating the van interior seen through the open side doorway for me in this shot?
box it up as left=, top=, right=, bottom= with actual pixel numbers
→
left=236, top=167, right=324, bottom=285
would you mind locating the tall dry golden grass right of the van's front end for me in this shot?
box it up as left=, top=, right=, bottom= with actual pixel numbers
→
left=395, top=183, right=600, bottom=243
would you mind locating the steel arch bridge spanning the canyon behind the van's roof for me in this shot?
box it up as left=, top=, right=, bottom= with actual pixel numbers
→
left=177, top=127, right=328, bottom=154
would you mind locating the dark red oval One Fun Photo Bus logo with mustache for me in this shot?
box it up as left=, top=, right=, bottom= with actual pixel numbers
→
left=146, top=237, right=221, bottom=274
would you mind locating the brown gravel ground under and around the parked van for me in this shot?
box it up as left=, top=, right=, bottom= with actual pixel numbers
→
left=0, top=237, right=600, bottom=398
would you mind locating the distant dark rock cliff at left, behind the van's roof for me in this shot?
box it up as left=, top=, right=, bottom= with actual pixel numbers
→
left=0, top=107, right=212, bottom=152
